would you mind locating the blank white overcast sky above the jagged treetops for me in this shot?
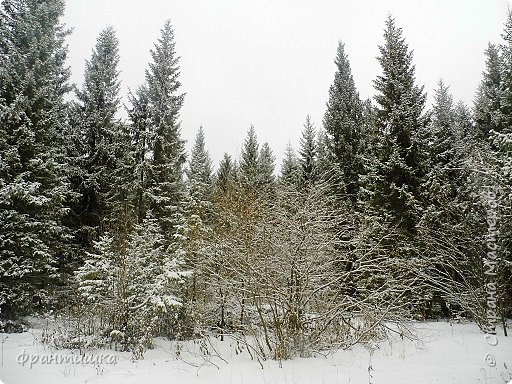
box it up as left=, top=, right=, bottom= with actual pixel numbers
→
left=64, top=0, right=510, bottom=169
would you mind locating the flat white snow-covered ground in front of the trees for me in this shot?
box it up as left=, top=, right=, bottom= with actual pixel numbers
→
left=0, top=322, right=512, bottom=384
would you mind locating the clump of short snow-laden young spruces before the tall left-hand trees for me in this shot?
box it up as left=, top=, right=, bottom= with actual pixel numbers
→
left=76, top=220, right=188, bottom=348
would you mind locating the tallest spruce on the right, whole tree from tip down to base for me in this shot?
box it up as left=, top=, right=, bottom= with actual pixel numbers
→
left=356, top=17, right=429, bottom=314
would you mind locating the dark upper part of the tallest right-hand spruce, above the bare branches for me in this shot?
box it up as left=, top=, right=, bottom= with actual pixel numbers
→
left=368, top=16, right=428, bottom=234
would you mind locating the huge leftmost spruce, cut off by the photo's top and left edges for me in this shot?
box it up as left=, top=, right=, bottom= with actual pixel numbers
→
left=0, top=0, right=69, bottom=318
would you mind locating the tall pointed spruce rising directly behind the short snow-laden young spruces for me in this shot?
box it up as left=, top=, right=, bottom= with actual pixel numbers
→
left=131, top=20, right=186, bottom=245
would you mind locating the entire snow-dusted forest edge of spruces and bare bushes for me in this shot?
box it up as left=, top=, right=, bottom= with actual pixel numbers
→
left=0, top=0, right=512, bottom=358
